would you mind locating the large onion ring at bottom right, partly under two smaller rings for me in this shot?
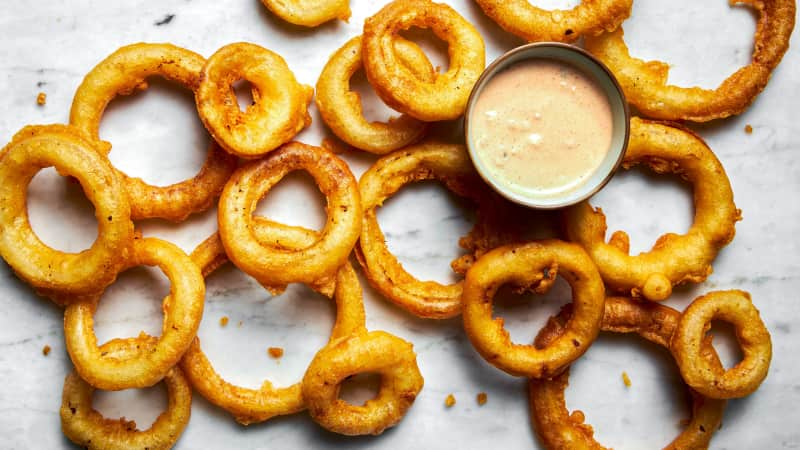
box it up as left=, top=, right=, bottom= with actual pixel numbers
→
left=530, top=297, right=726, bottom=450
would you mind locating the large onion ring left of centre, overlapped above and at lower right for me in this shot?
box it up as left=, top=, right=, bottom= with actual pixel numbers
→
left=181, top=225, right=366, bottom=425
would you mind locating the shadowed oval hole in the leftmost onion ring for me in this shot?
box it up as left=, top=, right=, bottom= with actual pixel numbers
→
left=26, top=167, right=98, bottom=253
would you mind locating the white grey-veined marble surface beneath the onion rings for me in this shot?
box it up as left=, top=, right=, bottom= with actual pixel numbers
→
left=0, top=0, right=800, bottom=450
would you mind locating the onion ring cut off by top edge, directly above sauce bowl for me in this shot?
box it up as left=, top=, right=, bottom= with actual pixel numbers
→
left=475, top=0, right=633, bottom=42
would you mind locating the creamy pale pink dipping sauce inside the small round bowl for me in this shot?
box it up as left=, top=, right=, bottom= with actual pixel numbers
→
left=470, top=60, right=613, bottom=197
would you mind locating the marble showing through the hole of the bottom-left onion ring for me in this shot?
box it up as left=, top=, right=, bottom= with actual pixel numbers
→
left=92, top=383, right=168, bottom=430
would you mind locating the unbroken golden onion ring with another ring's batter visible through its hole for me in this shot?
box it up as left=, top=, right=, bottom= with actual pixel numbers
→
left=219, top=142, right=361, bottom=290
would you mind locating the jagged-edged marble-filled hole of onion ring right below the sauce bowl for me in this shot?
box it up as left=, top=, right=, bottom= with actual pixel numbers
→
left=591, top=168, right=694, bottom=255
